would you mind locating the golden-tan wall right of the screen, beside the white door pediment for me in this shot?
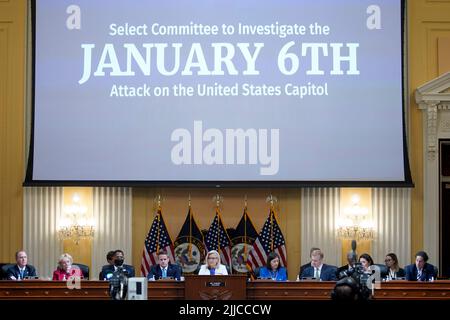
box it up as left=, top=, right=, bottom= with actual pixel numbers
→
left=407, top=0, right=450, bottom=256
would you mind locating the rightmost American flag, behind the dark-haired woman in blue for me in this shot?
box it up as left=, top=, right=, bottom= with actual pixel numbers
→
left=247, top=208, right=287, bottom=271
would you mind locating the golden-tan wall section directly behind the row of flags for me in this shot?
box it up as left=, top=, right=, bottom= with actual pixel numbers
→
left=132, top=188, right=301, bottom=279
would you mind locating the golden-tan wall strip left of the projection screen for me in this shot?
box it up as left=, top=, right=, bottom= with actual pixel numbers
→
left=0, top=0, right=27, bottom=262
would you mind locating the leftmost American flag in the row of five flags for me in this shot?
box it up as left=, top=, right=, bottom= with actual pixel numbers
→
left=141, top=209, right=175, bottom=277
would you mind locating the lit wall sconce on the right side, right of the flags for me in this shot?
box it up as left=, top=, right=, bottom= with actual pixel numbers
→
left=337, top=194, right=374, bottom=245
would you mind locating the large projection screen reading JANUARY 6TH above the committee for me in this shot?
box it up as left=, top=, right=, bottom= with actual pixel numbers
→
left=25, top=0, right=411, bottom=186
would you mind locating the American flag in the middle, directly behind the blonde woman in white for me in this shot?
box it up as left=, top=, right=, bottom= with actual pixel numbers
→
left=205, top=208, right=231, bottom=266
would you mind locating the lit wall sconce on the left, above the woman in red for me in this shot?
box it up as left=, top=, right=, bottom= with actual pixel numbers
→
left=58, top=193, right=94, bottom=245
